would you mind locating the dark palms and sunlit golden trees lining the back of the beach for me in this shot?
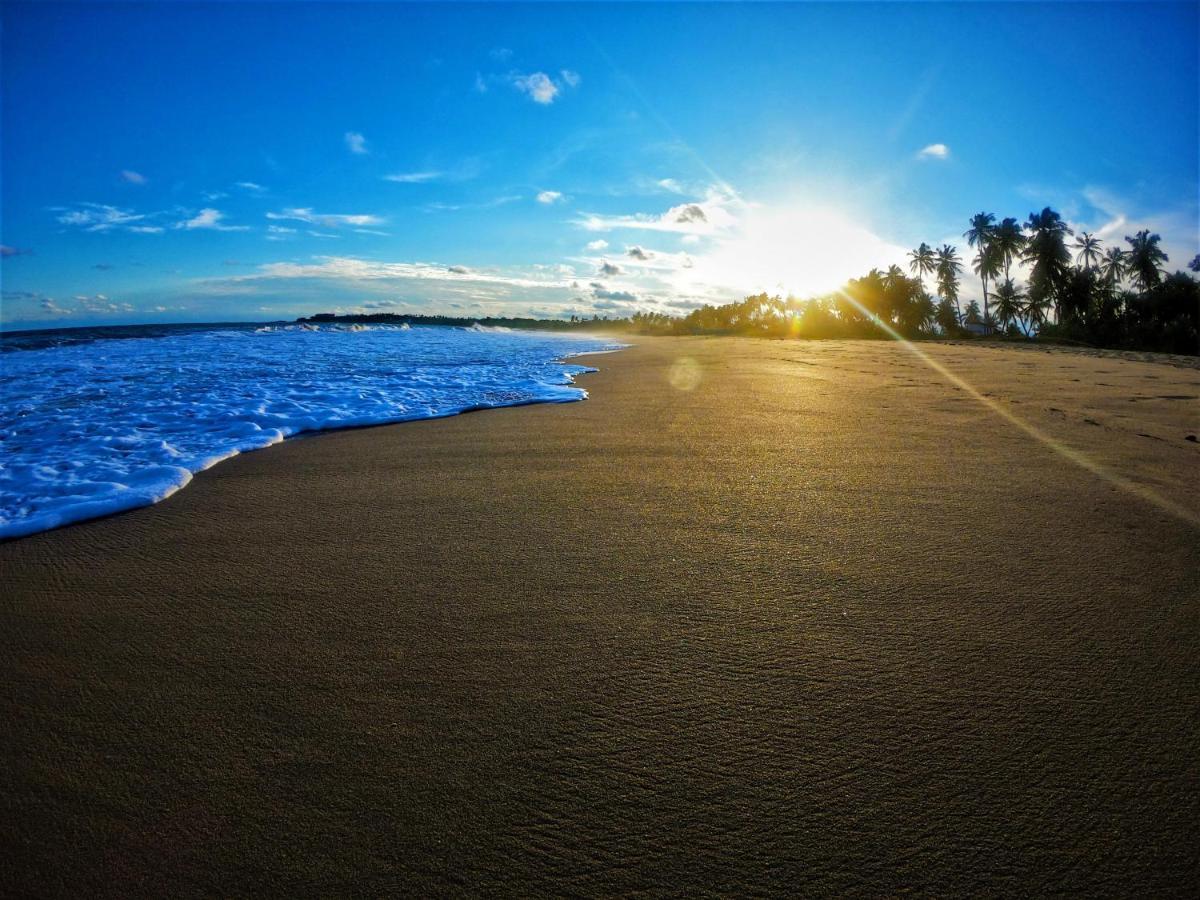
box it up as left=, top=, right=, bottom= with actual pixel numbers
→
left=613, top=206, right=1200, bottom=354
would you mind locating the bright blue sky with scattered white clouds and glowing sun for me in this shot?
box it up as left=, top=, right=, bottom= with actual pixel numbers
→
left=0, top=2, right=1200, bottom=328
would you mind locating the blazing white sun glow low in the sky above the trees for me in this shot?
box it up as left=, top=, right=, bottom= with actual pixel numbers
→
left=697, top=205, right=905, bottom=298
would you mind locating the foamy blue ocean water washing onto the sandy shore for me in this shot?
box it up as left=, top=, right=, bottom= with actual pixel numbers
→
left=0, top=325, right=617, bottom=538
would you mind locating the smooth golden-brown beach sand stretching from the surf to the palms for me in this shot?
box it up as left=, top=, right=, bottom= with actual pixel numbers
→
left=0, top=338, right=1200, bottom=896
